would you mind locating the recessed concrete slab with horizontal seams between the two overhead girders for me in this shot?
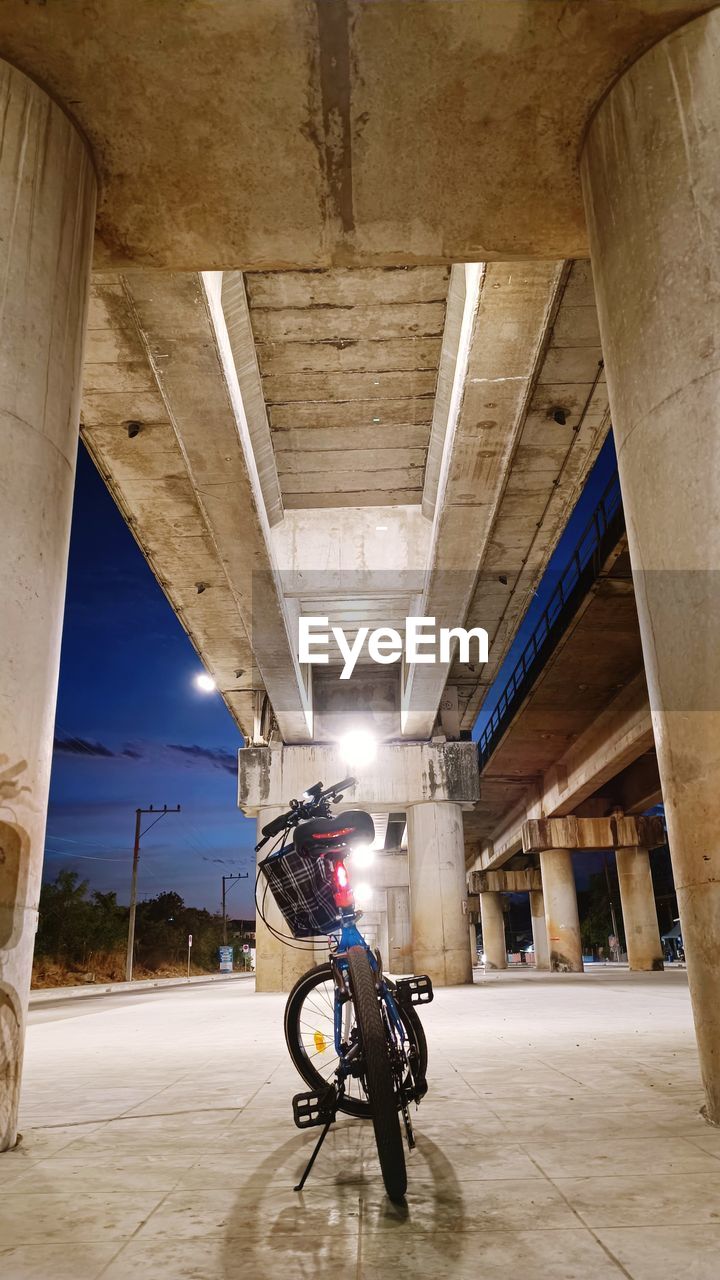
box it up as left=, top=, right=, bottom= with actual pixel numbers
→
left=245, top=266, right=450, bottom=509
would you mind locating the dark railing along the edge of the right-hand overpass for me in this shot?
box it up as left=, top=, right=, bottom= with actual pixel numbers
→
left=478, top=471, right=625, bottom=771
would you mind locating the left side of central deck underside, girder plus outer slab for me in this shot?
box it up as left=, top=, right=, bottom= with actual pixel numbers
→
left=82, top=271, right=311, bottom=741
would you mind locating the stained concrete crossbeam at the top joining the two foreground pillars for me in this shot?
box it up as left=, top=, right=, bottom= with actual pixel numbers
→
left=0, top=0, right=714, bottom=270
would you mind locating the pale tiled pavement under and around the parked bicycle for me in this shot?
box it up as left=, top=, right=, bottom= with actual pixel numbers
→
left=0, top=970, right=720, bottom=1280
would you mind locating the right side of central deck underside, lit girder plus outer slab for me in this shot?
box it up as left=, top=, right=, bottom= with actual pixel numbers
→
left=402, top=261, right=609, bottom=737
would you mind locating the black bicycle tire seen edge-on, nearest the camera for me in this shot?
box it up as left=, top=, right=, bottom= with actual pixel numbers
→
left=347, top=947, right=407, bottom=1201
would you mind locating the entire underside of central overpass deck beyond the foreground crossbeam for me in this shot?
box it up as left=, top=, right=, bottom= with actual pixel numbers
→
left=82, top=261, right=609, bottom=742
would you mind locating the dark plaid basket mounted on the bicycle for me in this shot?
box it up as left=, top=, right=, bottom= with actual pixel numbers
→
left=260, top=849, right=338, bottom=938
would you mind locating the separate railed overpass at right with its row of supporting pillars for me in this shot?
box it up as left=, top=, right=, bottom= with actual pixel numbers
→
left=464, top=488, right=666, bottom=972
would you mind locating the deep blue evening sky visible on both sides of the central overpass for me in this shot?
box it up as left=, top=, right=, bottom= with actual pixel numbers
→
left=45, top=438, right=615, bottom=916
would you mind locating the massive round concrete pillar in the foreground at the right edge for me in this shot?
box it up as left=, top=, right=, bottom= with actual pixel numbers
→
left=582, top=9, right=720, bottom=1124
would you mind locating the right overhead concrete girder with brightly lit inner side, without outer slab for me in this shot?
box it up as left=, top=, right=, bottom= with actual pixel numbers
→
left=401, top=262, right=565, bottom=737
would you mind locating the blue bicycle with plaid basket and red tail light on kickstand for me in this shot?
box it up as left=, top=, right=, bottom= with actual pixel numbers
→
left=255, top=778, right=433, bottom=1201
